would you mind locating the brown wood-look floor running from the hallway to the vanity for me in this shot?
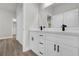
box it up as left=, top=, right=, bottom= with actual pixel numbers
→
left=0, top=38, right=36, bottom=56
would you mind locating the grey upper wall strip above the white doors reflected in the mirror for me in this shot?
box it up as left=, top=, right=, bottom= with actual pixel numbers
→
left=50, top=3, right=79, bottom=15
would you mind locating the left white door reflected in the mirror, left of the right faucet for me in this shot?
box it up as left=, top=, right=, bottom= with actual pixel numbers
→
left=51, top=14, right=63, bottom=28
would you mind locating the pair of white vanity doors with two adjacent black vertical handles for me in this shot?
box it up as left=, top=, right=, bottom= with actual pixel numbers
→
left=46, top=36, right=78, bottom=56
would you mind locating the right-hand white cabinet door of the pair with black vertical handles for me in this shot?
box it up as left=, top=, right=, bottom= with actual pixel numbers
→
left=51, top=43, right=78, bottom=56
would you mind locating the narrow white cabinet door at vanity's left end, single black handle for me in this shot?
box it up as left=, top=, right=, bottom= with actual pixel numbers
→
left=30, top=32, right=39, bottom=54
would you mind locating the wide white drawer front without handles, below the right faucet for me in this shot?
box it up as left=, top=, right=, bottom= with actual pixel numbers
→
left=46, top=34, right=78, bottom=47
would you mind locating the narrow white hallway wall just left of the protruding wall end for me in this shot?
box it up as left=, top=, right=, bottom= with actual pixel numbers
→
left=16, top=4, right=23, bottom=44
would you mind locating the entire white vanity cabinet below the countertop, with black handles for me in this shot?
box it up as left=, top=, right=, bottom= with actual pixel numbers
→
left=30, top=31, right=79, bottom=56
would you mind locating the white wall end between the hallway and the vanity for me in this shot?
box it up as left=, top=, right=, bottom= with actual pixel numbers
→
left=23, top=3, right=38, bottom=51
